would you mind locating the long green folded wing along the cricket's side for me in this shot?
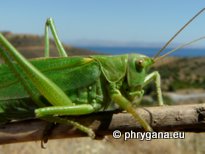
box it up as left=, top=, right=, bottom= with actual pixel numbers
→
left=0, top=57, right=101, bottom=100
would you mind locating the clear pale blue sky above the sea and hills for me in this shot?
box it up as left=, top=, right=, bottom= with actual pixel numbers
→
left=0, top=0, right=205, bottom=46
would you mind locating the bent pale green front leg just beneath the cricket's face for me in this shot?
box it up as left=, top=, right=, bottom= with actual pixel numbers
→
left=143, top=71, right=164, bottom=105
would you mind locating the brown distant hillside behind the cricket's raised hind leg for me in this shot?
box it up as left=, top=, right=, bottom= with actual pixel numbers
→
left=2, top=32, right=96, bottom=58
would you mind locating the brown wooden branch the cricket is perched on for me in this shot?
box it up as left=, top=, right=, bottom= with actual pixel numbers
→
left=0, top=104, right=205, bottom=144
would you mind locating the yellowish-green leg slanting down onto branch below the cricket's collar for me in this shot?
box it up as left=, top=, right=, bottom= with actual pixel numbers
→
left=111, top=89, right=153, bottom=131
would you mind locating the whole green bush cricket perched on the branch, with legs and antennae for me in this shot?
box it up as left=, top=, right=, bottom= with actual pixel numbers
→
left=0, top=9, right=204, bottom=146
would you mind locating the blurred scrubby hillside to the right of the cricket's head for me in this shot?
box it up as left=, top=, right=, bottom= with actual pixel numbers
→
left=152, top=57, right=205, bottom=91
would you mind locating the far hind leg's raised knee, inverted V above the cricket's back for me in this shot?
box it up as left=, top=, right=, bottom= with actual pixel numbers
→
left=44, top=18, right=68, bottom=57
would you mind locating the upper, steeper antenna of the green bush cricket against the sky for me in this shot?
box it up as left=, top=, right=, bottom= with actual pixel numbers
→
left=153, top=8, right=205, bottom=59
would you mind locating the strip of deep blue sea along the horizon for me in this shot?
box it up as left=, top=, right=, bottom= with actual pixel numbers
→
left=81, top=47, right=205, bottom=57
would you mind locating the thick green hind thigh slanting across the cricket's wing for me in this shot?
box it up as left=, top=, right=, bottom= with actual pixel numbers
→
left=0, top=34, right=73, bottom=106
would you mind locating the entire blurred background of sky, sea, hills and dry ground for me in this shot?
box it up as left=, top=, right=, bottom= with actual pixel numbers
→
left=0, top=0, right=205, bottom=154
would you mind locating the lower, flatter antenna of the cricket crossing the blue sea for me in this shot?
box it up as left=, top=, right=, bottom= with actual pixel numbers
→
left=154, top=36, right=205, bottom=62
